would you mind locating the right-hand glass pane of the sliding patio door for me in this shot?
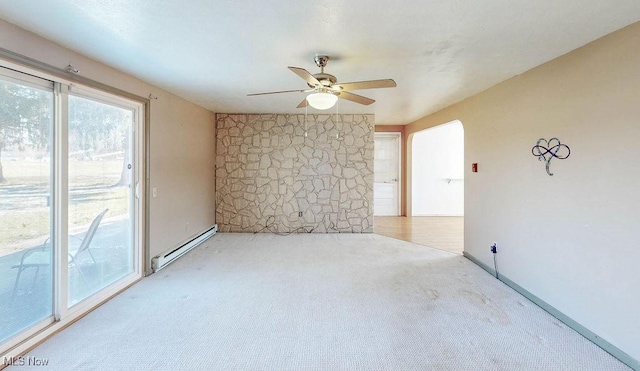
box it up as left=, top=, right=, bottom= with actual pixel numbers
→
left=67, top=96, right=134, bottom=307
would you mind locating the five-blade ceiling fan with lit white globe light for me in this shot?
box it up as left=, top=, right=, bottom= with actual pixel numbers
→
left=248, top=55, right=396, bottom=110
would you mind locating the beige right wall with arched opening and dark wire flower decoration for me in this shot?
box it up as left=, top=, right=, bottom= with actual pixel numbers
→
left=407, top=23, right=640, bottom=360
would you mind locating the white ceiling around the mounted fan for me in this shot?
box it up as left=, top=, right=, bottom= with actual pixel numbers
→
left=0, top=0, right=640, bottom=124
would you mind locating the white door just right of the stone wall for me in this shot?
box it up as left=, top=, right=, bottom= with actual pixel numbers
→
left=373, top=133, right=400, bottom=216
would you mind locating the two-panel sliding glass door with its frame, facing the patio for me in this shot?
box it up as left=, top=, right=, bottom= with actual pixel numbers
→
left=0, top=67, right=144, bottom=355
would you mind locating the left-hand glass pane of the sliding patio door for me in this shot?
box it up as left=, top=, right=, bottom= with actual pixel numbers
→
left=0, top=75, right=54, bottom=343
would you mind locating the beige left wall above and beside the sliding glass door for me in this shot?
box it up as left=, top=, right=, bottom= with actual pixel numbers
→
left=0, top=20, right=215, bottom=268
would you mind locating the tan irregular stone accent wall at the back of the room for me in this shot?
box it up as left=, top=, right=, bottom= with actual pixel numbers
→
left=216, top=114, right=374, bottom=233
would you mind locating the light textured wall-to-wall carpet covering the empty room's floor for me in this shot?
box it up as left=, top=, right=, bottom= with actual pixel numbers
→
left=8, top=233, right=629, bottom=371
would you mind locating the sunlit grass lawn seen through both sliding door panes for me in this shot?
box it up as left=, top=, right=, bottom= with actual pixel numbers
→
left=0, top=160, right=129, bottom=256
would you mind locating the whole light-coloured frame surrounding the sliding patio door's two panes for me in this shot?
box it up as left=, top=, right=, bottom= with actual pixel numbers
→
left=0, top=54, right=150, bottom=359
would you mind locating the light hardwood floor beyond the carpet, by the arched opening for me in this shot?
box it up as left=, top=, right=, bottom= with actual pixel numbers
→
left=373, top=216, right=464, bottom=254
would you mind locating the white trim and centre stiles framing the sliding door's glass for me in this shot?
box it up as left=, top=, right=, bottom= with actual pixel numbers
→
left=0, top=62, right=148, bottom=358
